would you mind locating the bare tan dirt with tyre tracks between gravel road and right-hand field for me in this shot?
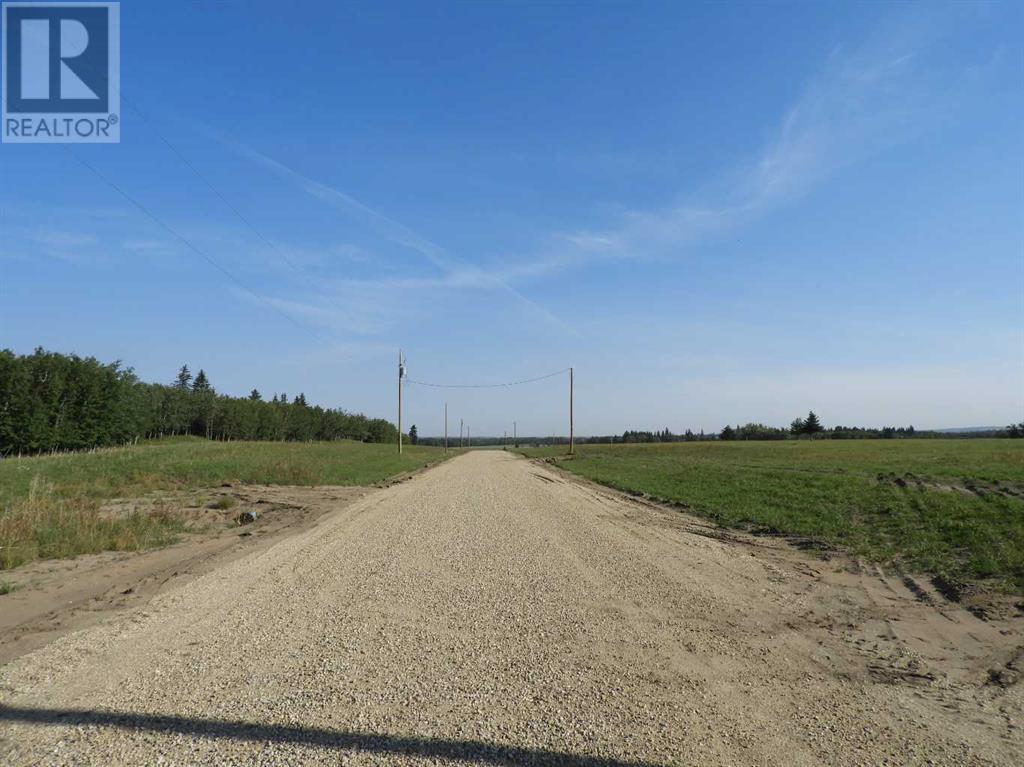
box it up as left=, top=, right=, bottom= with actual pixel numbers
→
left=538, top=460, right=1024, bottom=692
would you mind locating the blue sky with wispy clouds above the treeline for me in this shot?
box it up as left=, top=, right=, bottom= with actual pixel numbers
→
left=0, top=1, right=1024, bottom=435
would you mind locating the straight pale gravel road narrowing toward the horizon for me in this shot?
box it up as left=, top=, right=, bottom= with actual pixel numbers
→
left=0, top=451, right=1024, bottom=767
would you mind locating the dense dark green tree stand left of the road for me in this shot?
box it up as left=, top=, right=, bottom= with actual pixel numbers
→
left=0, top=348, right=398, bottom=456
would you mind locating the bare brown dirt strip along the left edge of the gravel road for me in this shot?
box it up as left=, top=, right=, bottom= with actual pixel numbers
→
left=0, top=483, right=374, bottom=664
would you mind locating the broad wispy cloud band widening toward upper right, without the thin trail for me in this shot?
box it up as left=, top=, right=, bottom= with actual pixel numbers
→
left=498, top=6, right=947, bottom=281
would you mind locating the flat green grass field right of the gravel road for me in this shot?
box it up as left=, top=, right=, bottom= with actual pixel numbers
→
left=523, top=439, right=1024, bottom=592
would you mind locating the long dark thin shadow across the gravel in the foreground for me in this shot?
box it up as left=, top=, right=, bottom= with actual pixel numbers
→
left=0, top=705, right=660, bottom=767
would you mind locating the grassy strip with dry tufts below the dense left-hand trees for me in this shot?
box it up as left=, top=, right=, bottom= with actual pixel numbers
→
left=0, top=437, right=444, bottom=569
